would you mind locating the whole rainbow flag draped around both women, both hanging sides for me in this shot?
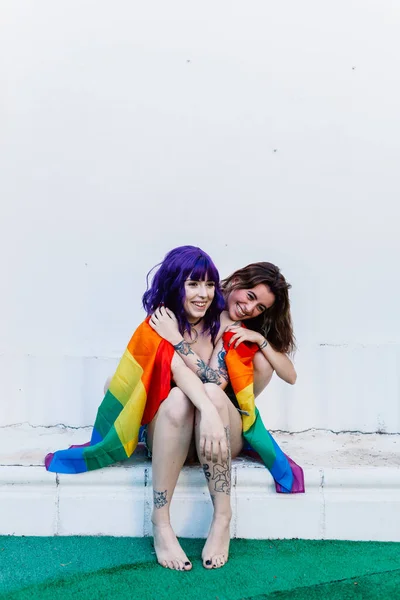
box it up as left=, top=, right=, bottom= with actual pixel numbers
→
left=45, top=319, right=304, bottom=493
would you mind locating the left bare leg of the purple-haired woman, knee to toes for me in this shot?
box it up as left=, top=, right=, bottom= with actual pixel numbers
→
left=148, top=388, right=194, bottom=571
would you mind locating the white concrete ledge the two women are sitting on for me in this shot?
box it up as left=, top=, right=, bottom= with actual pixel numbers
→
left=0, top=426, right=400, bottom=541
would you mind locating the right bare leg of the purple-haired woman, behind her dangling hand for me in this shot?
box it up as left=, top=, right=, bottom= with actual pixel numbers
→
left=195, top=383, right=243, bottom=569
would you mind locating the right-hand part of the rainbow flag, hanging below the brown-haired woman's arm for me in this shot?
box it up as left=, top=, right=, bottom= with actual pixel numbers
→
left=223, top=332, right=304, bottom=494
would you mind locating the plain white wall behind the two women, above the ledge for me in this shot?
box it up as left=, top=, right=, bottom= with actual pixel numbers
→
left=0, top=0, right=400, bottom=432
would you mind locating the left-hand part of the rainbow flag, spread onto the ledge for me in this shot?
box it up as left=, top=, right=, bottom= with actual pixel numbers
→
left=45, top=320, right=174, bottom=473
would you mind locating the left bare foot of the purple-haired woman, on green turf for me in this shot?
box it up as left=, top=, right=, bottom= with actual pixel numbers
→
left=153, top=523, right=192, bottom=571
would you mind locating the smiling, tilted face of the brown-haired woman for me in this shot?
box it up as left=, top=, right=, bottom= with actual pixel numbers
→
left=226, top=283, right=275, bottom=321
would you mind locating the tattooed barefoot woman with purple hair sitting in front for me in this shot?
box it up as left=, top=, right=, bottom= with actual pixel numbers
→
left=143, top=246, right=236, bottom=570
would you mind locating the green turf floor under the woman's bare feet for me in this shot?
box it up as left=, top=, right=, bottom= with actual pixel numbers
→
left=0, top=537, right=400, bottom=600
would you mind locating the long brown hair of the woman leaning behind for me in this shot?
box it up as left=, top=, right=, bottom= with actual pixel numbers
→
left=221, top=262, right=296, bottom=354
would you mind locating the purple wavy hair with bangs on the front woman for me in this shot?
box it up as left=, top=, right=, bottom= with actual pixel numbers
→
left=142, top=246, right=225, bottom=343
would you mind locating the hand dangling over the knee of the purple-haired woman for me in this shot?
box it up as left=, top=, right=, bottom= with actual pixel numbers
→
left=199, top=405, right=228, bottom=463
